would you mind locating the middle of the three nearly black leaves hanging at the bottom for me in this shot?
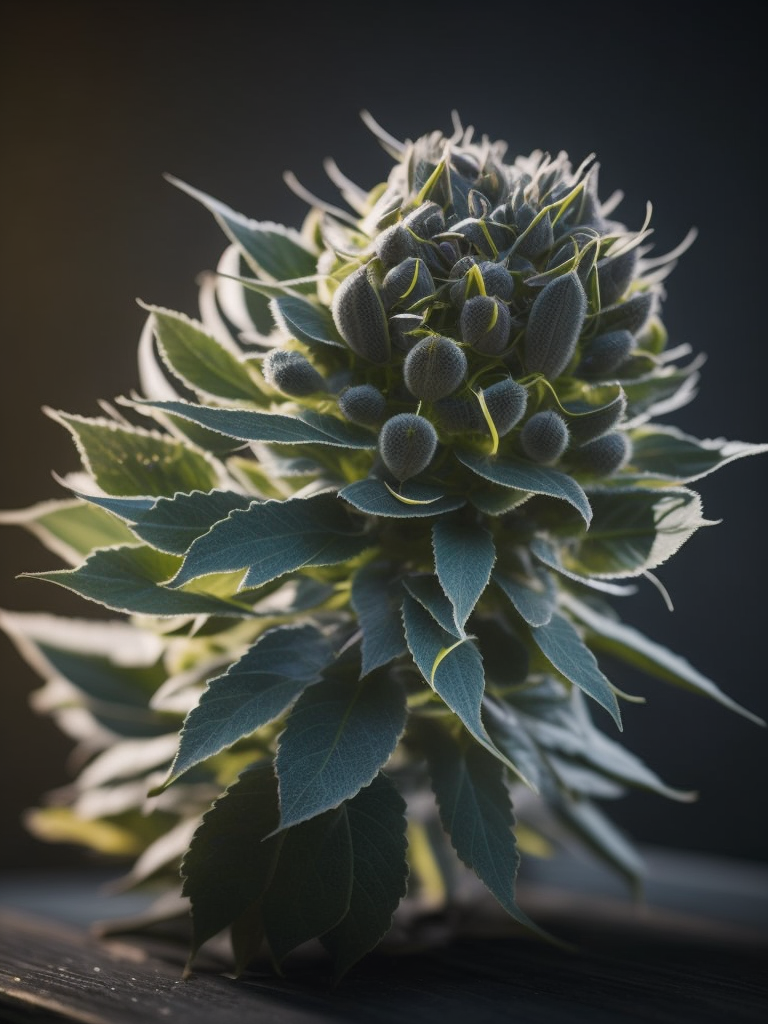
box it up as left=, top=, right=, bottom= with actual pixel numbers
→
left=263, top=807, right=353, bottom=965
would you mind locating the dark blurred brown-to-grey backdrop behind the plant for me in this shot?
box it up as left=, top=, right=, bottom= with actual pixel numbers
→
left=0, top=0, right=768, bottom=868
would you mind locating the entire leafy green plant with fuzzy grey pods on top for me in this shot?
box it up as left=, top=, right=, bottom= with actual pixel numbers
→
left=2, top=110, right=768, bottom=977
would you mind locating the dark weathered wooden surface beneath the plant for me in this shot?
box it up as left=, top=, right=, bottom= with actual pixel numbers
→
left=0, top=847, right=768, bottom=1024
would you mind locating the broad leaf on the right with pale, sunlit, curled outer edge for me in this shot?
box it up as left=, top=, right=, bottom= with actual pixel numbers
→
left=564, top=487, right=710, bottom=579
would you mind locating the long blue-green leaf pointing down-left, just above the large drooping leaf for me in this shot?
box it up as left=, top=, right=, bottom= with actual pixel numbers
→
left=160, top=626, right=334, bottom=788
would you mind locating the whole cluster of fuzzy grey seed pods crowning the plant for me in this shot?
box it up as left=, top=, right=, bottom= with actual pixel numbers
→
left=264, top=144, right=655, bottom=481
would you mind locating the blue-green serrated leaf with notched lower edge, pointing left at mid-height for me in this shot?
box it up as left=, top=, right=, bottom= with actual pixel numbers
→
left=173, top=492, right=370, bottom=588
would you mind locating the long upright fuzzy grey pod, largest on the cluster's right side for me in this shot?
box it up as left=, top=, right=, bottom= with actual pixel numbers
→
left=525, top=270, right=587, bottom=380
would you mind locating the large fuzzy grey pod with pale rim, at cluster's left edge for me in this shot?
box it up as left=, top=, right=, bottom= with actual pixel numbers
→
left=331, top=263, right=389, bottom=364
